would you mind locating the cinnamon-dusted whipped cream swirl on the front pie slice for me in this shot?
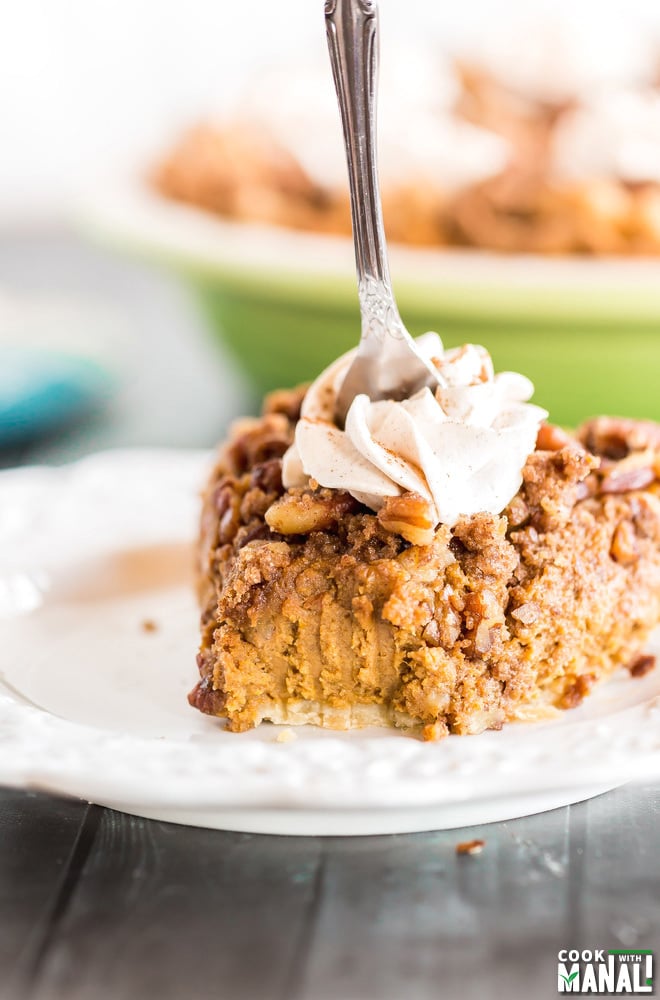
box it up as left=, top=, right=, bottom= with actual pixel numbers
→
left=283, top=333, right=548, bottom=526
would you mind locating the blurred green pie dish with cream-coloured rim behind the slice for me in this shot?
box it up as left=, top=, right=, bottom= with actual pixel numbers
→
left=88, top=191, right=660, bottom=426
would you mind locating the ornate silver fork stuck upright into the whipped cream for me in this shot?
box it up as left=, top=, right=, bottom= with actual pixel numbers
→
left=325, top=0, right=440, bottom=427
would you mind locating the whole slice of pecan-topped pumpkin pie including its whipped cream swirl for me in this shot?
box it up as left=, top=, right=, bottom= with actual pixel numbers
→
left=189, top=335, right=660, bottom=739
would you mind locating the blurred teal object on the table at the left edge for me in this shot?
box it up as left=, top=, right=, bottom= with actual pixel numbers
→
left=0, top=345, right=113, bottom=448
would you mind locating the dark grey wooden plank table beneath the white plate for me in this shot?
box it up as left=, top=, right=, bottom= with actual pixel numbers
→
left=0, top=232, right=660, bottom=1000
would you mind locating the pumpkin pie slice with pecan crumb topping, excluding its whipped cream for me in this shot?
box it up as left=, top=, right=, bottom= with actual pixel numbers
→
left=189, top=374, right=660, bottom=739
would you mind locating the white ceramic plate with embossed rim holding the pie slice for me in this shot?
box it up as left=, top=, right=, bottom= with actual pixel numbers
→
left=0, top=452, right=660, bottom=834
